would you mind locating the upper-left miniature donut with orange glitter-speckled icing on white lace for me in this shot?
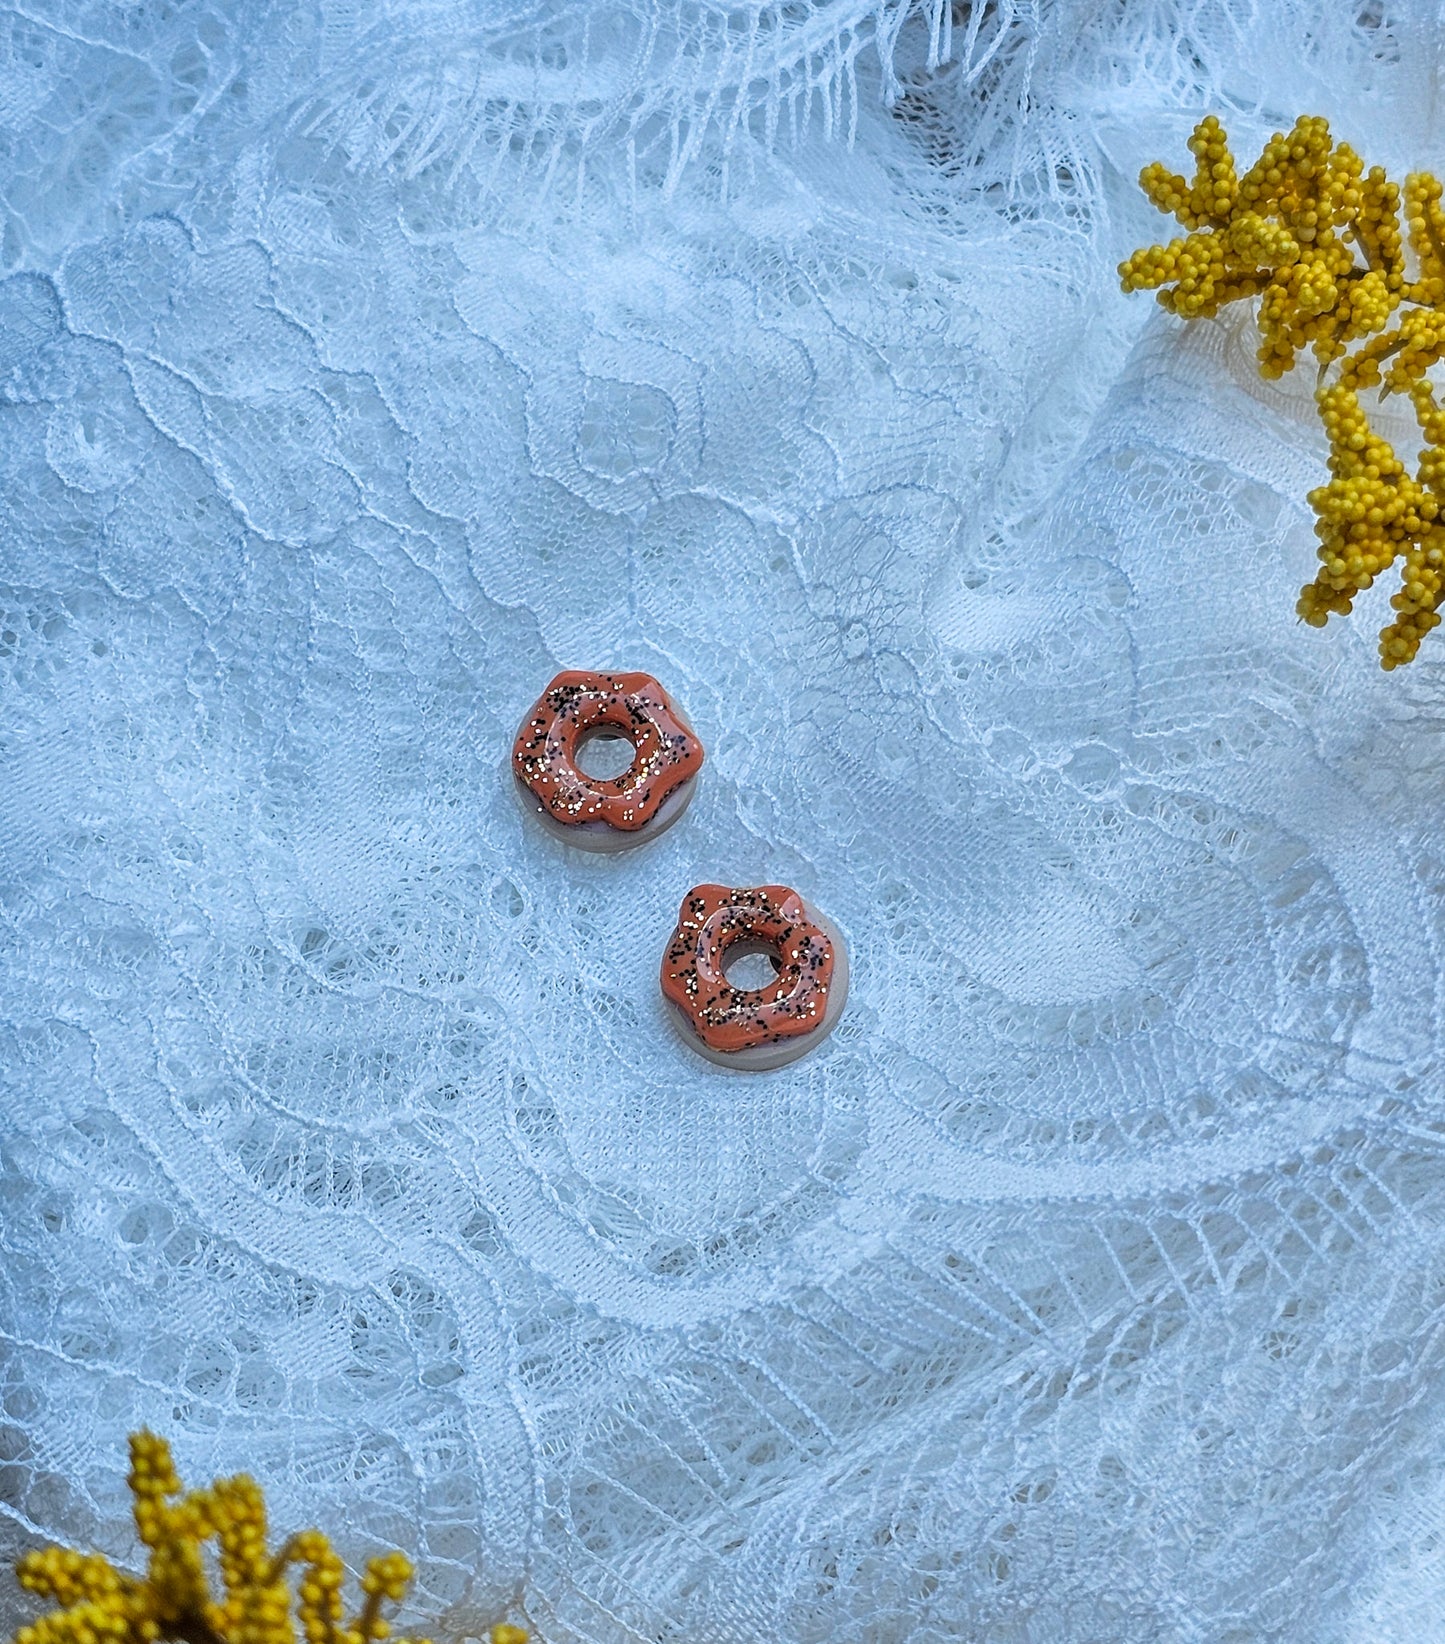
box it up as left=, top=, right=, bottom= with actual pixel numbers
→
left=511, top=672, right=702, bottom=850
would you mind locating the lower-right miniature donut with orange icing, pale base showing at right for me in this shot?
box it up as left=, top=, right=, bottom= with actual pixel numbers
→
left=662, top=884, right=848, bottom=1072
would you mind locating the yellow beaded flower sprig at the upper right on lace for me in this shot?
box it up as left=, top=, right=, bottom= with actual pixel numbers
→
left=1120, top=115, right=1445, bottom=669
